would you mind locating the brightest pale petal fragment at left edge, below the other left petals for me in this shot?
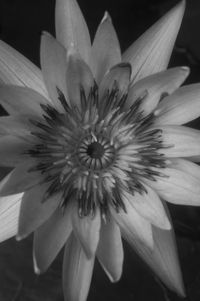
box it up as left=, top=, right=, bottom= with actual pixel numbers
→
left=0, top=193, right=23, bottom=242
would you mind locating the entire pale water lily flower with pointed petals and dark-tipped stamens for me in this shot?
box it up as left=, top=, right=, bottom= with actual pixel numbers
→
left=0, top=0, right=200, bottom=301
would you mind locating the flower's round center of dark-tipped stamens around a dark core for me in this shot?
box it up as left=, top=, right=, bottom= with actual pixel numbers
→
left=28, top=74, right=169, bottom=216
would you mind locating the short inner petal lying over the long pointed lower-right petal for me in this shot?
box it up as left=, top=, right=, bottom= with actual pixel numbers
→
left=127, top=185, right=171, bottom=230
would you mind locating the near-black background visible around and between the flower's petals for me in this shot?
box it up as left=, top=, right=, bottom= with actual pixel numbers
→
left=0, top=0, right=200, bottom=301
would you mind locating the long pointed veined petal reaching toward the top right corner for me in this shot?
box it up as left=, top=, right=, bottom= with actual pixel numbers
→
left=122, top=1, right=185, bottom=81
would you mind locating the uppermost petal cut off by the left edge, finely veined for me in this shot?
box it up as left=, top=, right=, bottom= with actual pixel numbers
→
left=0, top=41, right=48, bottom=97
